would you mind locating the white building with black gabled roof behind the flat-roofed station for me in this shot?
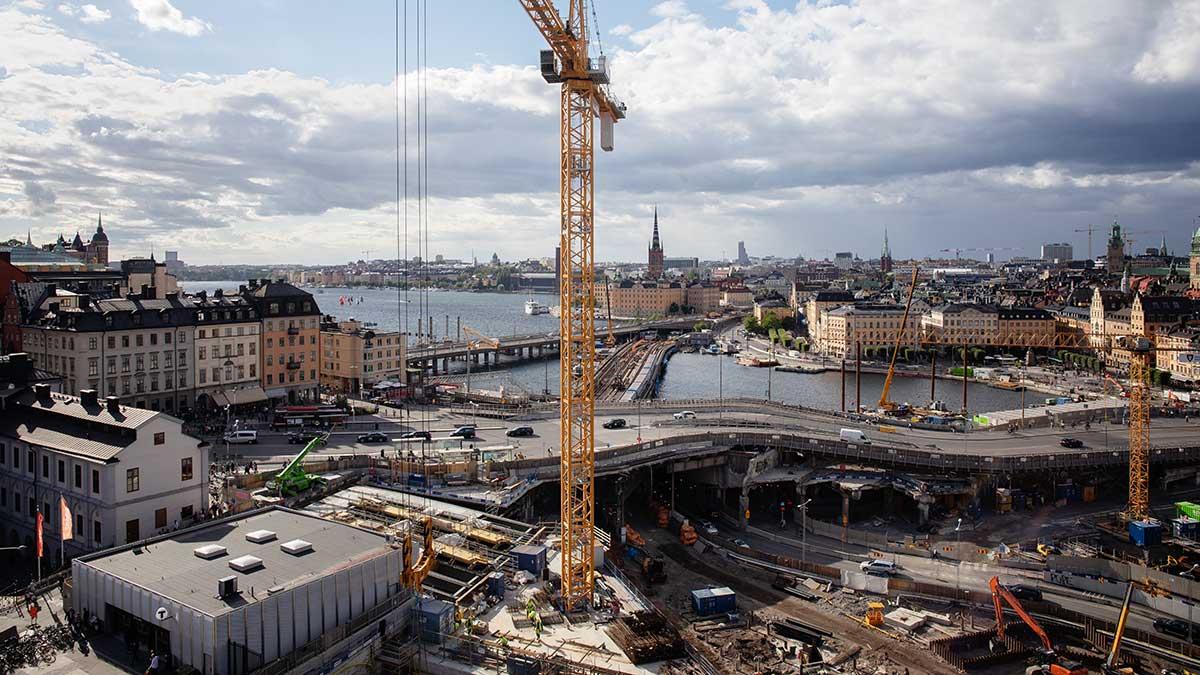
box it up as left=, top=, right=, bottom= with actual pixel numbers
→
left=0, top=365, right=209, bottom=560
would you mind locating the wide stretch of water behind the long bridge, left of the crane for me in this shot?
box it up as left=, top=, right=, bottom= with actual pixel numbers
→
left=180, top=281, right=558, bottom=340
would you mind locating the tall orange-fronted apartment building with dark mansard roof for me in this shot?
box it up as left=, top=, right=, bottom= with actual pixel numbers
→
left=239, top=279, right=320, bottom=402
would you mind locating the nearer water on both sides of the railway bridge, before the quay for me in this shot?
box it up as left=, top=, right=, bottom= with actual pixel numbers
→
left=482, top=352, right=1033, bottom=412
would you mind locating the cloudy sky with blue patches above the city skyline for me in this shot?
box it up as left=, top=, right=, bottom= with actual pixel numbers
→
left=0, top=0, right=1200, bottom=264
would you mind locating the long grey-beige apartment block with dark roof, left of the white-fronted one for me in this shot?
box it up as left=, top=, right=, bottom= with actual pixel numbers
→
left=22, top=285, right=196, bottom=413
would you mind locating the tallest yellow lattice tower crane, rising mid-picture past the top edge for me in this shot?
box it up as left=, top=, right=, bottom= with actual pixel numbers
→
left=518, top=0, right=625, bottom=609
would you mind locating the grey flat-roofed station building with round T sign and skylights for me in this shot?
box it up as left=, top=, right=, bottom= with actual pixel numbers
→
left=71, top=507, right=414, bottom=675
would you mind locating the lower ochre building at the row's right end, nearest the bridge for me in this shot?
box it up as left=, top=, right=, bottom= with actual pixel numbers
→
left=320, top=316, right=406, bottom=395
